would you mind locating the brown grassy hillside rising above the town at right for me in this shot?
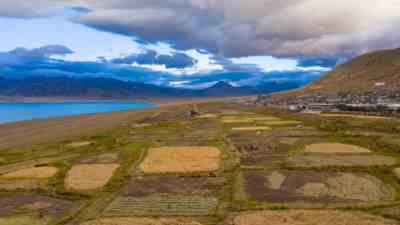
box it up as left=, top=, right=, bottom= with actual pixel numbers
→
left=303, top=49, right=400, bottom=92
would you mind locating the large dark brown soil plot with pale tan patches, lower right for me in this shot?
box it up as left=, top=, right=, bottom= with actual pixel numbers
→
left=243, top=171, right=394, bottom=204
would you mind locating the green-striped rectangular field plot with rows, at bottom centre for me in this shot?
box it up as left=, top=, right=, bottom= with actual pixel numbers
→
left=104, top=196, right=218, bottom=216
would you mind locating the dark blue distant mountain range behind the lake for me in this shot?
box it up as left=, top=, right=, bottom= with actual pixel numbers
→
left=0, top=77, right=304, bottom=99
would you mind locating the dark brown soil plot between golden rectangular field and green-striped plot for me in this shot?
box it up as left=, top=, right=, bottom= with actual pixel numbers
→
left=122, top=175, right=226, bottom=197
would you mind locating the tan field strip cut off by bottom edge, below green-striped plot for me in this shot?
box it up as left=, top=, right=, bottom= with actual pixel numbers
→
left=80, top=217, right=201, bottom=225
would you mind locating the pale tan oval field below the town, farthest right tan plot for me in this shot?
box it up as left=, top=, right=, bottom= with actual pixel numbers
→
left=304, top=143, right=371, bottom=154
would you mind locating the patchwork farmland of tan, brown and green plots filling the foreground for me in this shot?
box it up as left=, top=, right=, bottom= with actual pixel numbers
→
left=0, top=101, right=400, bottom=225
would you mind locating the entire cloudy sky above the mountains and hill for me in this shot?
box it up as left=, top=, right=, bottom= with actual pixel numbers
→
left=0, top=0, right=400, bottom=88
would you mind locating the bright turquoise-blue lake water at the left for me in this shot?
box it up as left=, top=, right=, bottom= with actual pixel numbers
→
left=0, top=101, right=158, bottom=124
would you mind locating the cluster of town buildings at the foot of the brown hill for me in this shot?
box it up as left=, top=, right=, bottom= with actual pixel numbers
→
left=253, top=90, right=400, bottom=112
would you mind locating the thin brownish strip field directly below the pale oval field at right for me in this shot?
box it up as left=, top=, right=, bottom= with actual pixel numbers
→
left=287, top=154, right=398, bottom=167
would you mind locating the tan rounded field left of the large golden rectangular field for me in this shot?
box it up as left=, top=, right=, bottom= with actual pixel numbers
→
left=65, top=164, right=119, bottom=191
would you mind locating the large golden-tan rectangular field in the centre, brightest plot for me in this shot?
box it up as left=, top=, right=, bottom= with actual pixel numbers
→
left=140, top=147, right=221, bottom=173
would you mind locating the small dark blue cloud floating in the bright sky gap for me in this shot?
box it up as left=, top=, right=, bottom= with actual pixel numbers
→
left=112, top=50, right=196, bottom=69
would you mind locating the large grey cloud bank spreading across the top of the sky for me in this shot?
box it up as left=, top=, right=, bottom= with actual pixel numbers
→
left=0, top=0, right=400, bottom=57
